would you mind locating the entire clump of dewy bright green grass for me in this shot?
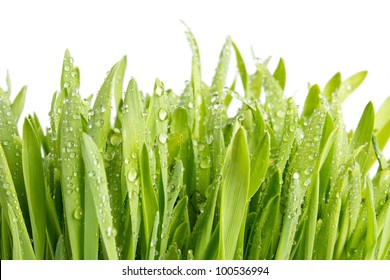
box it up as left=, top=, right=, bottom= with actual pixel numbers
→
left=0, top=29, right=390, bottom=260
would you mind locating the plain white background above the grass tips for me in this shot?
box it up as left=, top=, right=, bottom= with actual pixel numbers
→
left=0, top=0, right=390, bottom=156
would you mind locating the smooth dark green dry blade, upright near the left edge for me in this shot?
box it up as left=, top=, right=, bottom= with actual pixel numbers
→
left=22, top=118, right=46, bottom=260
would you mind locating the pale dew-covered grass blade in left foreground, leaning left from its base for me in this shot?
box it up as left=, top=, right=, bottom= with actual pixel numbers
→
left=82, top=133, right=118, bottom=260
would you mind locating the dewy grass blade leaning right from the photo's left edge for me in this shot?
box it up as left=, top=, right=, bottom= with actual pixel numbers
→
left=0, top=145, right=35, bottom=260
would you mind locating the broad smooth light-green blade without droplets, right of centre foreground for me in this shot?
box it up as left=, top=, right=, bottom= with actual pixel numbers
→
left=218, top=128, right=250, bottom=259
